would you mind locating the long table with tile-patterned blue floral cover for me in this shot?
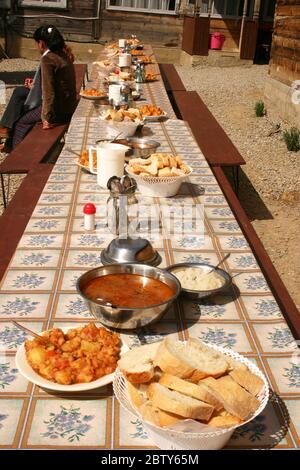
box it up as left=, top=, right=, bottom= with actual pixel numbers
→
left=0, top=46, right=300, bottom=449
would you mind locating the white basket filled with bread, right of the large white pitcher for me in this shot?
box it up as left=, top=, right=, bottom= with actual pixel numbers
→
left=125, top=152, right=192, bottom=197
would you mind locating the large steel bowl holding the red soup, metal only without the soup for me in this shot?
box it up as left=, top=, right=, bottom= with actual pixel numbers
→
left=76, top=264, right=181, bottom=330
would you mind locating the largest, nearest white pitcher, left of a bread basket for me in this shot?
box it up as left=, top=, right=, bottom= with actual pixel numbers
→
left=89, top=142, right=130, bottom=189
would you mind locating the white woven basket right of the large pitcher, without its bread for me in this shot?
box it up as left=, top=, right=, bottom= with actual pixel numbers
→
left=125, top=165, right=193, bottom=197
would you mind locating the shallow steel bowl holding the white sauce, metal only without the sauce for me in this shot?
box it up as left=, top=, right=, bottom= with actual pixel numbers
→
left=166, top=263, right=232, bottom=300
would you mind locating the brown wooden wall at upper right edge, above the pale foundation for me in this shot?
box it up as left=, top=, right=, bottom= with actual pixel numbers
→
left=270, top=0, right=300, bottom=85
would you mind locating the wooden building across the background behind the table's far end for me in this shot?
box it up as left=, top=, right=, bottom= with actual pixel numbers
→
left=0, top=0, right=275, bottom=61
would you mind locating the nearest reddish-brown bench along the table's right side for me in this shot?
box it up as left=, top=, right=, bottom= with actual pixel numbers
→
left=212, top=166, right=300, bottom=340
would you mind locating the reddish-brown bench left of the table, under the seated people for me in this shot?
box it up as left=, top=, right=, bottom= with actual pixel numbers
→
left=0, top=64, right=87, bottom=208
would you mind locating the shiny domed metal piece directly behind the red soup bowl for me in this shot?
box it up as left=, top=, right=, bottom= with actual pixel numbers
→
left=101, top=238, right=162, bottom=266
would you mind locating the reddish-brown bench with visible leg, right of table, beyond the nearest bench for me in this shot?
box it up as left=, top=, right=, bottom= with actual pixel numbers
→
left=173, top=91, right=246, bottom=194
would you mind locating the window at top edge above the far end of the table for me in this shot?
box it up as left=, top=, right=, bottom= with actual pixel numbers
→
left=106, top=0, right=179, bottom=15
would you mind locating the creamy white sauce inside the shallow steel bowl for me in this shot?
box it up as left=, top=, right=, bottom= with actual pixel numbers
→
left=172, top=266, right=225, bottom=291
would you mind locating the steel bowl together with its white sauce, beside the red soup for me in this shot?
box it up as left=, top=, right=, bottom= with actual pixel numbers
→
left=167, top=263, right=232, bottom=300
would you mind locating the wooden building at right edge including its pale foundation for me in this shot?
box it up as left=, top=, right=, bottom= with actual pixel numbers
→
left=265, top=0, right=300, bottom=128
